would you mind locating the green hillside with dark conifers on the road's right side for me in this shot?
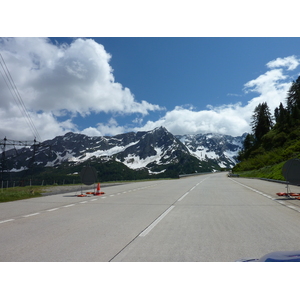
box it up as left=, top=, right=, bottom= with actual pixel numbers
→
left=233, top=76, right=300, bottom=180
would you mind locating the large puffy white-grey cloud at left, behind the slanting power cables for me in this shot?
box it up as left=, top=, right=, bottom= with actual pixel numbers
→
left=0, top=38, right=161, bottom=139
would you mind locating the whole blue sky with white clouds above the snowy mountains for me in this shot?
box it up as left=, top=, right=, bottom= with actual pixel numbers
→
left=0, top=37, right=300, bottom=140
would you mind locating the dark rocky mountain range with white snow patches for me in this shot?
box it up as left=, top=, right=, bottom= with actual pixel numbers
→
left=0, top=127, right=245, bottom=174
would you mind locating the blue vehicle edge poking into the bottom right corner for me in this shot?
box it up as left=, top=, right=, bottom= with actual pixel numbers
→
left=238, top=250, right=300, bottom=262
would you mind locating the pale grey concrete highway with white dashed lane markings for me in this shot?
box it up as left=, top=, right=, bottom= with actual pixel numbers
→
left=0, top=173, right=300, bottom=262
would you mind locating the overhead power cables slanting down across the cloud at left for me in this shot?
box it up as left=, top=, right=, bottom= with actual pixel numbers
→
left=0, top=53, right=41, bottom=140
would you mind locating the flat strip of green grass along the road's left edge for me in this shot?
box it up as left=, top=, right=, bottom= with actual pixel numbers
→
left=0, top=186, right=46, bottom=202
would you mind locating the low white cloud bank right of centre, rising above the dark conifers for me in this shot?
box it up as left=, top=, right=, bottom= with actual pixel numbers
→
left=135, top=56, right=299, bottom=136
